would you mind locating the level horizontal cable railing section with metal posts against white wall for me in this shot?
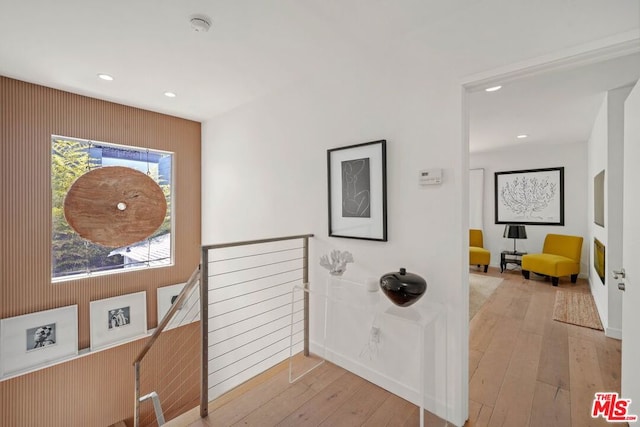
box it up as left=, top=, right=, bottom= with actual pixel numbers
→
left=200, top=234, right=313, bottom=417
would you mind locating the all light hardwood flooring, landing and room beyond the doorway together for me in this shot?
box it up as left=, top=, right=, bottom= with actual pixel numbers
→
left=167, top=268, right=620, bottom=427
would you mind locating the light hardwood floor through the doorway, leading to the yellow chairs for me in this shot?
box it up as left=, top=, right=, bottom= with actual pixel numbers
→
left=466, top=269, right=621, bottom=427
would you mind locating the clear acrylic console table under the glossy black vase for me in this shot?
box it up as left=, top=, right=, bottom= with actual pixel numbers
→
left=289, top=277, right=449, bottom=427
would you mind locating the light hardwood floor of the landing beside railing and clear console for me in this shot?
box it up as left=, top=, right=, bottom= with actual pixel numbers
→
left=165, top=362, right=446, bottom=427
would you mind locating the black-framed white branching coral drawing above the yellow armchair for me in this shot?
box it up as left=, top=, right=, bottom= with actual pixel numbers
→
left=495, top=167, right=564, bottom=225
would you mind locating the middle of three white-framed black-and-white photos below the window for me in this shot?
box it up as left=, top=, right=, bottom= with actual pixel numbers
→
left=89, top=291, right=147, bottom=350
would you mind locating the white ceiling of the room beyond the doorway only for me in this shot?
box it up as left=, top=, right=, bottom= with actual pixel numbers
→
left=469, top=53, right=640, bottom=152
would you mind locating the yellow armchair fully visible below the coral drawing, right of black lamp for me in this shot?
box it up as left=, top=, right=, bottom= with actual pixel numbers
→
left=522, top=234, right=582, bottom=286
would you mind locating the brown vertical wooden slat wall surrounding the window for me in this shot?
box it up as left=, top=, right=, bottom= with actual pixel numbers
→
left=0, top=76, right=201, bottom=427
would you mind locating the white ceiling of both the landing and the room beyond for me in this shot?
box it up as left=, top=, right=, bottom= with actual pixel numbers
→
left=0, top=0, right=640, bottom=150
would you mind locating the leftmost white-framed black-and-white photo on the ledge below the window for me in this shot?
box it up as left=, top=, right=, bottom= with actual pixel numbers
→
left=0, top=305, right=78, bottom=376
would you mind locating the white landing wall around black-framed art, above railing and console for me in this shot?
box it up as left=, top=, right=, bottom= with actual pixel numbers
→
left=202, top=61, right=468, bottom=424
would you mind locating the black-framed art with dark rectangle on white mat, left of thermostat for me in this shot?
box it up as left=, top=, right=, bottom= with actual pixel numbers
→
left=327, top=140, right=387, bottom=242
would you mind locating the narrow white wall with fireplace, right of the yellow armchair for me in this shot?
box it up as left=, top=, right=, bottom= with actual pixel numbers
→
left=588, top=86, right=632, bottom=338
